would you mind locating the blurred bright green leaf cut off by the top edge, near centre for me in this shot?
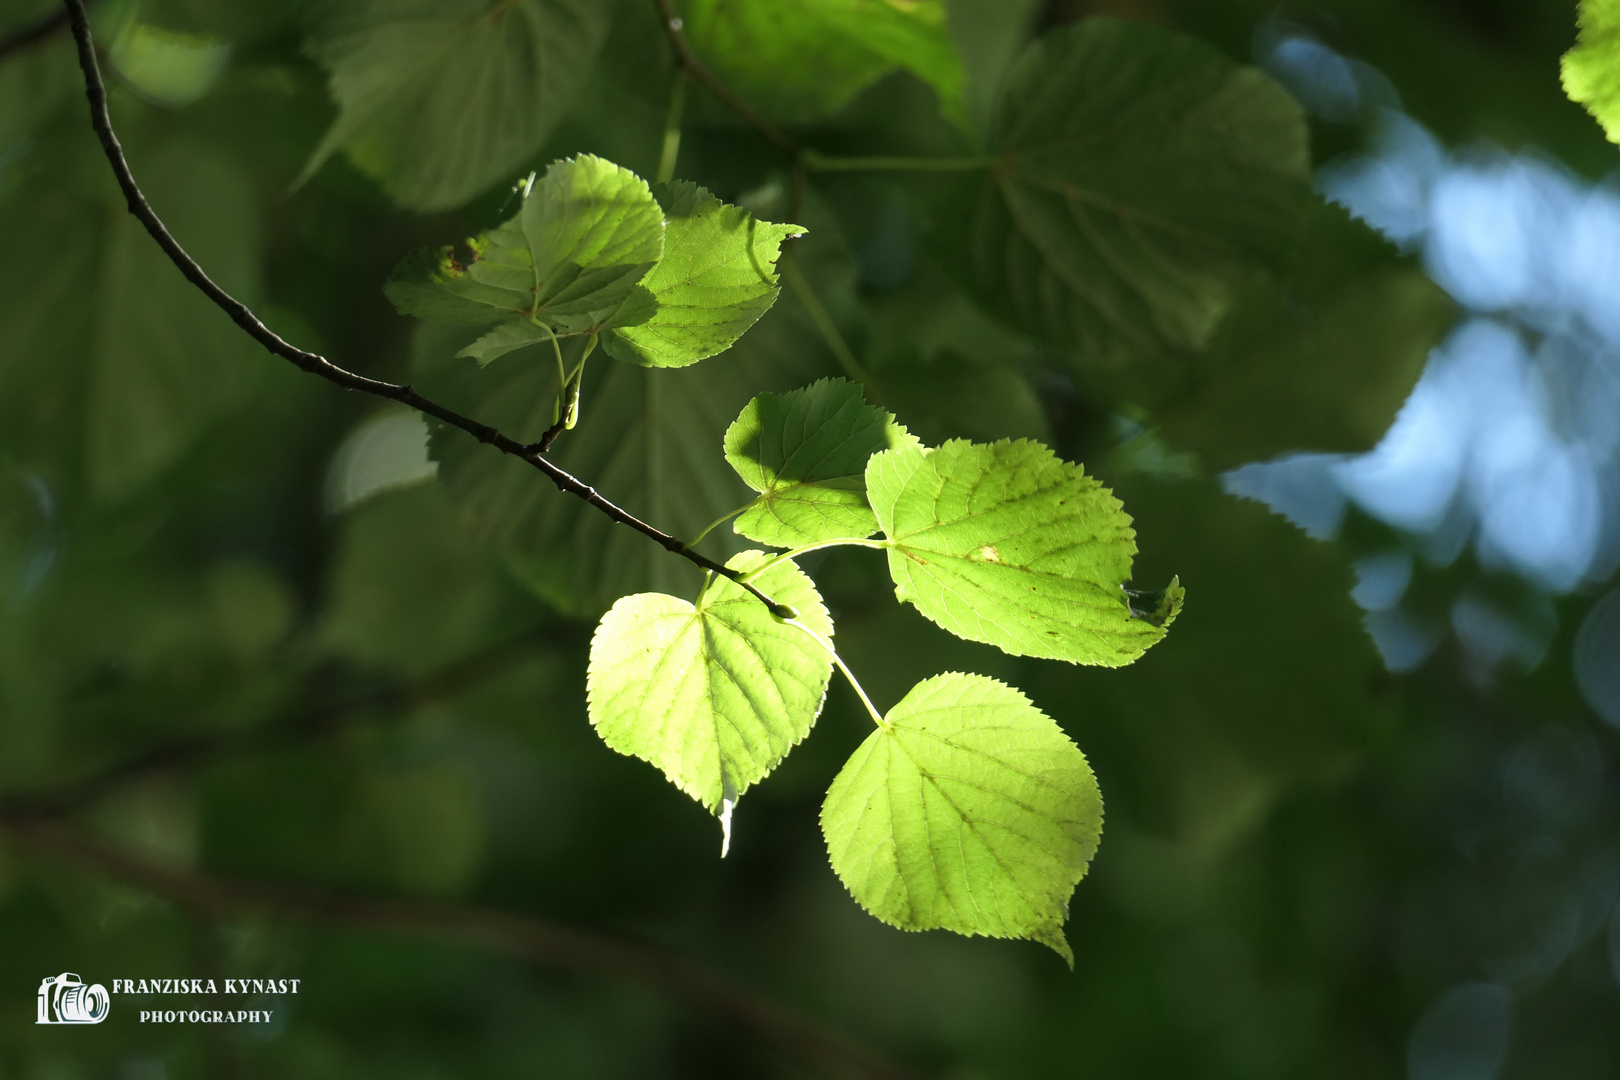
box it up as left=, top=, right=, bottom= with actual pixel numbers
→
left=685, top=0, right=962, bottom=121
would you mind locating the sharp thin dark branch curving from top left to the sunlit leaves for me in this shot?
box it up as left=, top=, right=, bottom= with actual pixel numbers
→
left=63, top=0, right=795, bottom=619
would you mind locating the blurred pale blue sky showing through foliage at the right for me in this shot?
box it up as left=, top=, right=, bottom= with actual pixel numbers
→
left=1223, top=23, right=1620, bottom=676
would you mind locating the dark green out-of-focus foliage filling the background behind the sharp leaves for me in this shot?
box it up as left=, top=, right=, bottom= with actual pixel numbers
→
left=0, top=0, right=1620, bottom=1080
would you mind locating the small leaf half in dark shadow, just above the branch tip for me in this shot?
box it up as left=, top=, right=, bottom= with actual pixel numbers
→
left=726, top=379, right=919, bottom=547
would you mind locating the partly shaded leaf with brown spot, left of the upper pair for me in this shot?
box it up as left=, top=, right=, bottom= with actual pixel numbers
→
left=384, top=154, right=664, bottom=364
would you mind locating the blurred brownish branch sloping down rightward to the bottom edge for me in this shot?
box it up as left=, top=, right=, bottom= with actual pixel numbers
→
left=0, top=818, right=922, bottom=1080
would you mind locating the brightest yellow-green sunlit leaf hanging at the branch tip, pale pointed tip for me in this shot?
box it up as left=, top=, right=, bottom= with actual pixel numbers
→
left=586, top=551, right=833, bottom=814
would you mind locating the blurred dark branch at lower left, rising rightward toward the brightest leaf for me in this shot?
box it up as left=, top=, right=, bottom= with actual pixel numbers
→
left=0, top=623, right=580, bottom=819
